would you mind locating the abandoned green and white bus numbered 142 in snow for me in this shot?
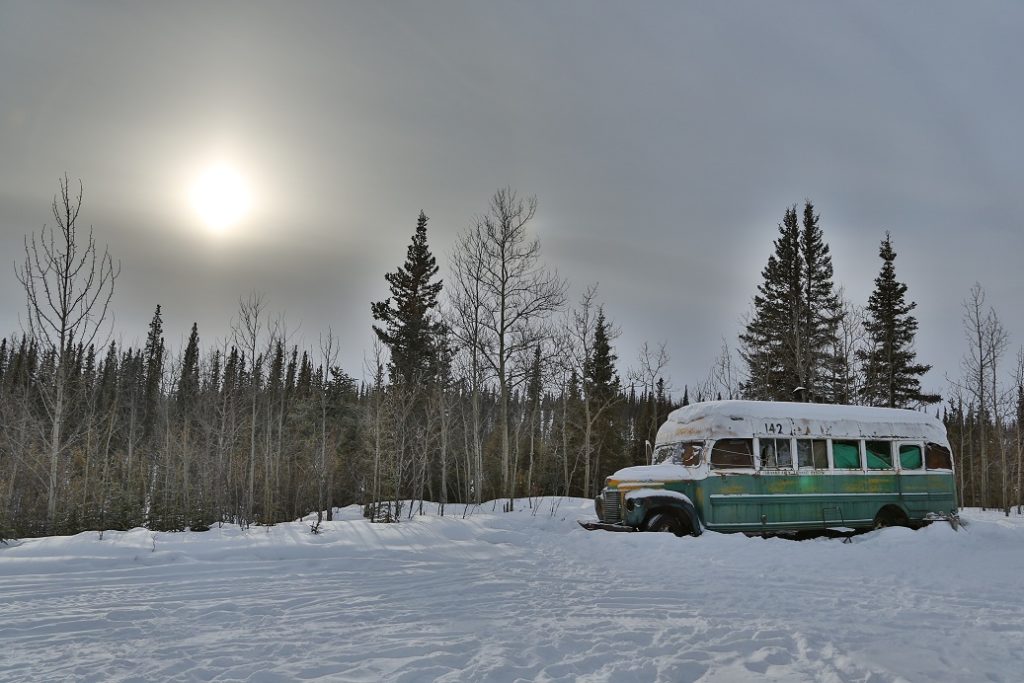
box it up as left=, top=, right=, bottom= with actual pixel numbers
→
left=581, top=400, right=957, bottom=536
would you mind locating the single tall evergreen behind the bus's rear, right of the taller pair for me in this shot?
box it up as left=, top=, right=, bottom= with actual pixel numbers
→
left=859, top=232, right=939, bottom=408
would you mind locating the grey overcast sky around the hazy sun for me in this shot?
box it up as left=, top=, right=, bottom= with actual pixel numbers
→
left=0, top=0, right=1024, bottom=391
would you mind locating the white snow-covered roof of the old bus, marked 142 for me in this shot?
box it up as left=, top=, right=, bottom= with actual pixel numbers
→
left=657, top=400, right=949, bottom=447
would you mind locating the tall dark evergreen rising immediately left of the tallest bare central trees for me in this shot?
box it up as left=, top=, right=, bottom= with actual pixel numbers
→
left=371, top=211, right=441, bottom=386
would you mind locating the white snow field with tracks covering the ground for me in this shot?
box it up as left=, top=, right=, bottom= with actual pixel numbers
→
left=0, top=499, right=1024, bottom=683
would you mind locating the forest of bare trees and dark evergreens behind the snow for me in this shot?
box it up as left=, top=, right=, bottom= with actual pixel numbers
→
left=0, top=178, right=1024, bottom=539
